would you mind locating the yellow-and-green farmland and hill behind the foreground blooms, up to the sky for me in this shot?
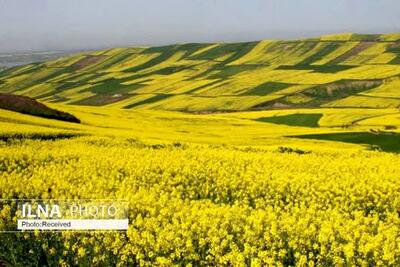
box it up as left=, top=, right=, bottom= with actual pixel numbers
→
left=0, top=34, right=400, bottom=152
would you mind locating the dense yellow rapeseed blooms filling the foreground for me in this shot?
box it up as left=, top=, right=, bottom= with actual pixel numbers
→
left=0, top=137, right=400, bottom=266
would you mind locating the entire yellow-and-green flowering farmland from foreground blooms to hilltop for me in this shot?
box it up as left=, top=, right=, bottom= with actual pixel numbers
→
left=0, top=34, right=400, bottom=266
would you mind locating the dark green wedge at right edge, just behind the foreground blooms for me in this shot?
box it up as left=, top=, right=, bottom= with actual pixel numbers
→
left=292, top=132, right=400, bottom=153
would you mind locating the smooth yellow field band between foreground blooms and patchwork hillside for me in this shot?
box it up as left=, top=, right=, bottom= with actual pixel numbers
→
left=0, top=104, right=400, bottom=151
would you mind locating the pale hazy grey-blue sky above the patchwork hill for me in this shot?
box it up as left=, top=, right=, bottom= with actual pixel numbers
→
left=0, top=0, right=400, bottom=53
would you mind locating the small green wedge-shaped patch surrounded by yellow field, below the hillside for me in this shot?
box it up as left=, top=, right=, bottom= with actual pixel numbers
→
left=256, top=113, right=323, bottom=127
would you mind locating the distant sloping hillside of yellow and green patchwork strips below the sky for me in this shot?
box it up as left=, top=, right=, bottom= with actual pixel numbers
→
left=0, top=34, right=400, bottom=112
